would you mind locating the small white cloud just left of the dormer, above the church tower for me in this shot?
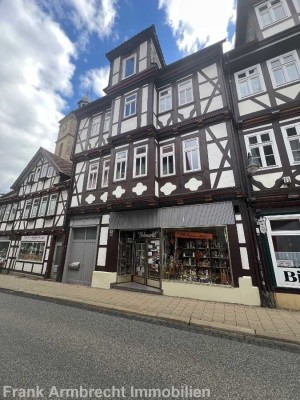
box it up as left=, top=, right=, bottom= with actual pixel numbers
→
left=80, top=66, right=109, bottom=97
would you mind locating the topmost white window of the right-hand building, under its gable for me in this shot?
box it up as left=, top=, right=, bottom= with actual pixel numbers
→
left=256, top=0, right=288, bottom=28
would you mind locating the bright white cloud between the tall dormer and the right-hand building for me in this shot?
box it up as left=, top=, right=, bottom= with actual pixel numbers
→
left=159, top=0, right=235, bottom=53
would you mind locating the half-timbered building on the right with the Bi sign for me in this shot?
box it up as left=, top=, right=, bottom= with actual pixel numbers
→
left=225, top=0, right=300, bottom=308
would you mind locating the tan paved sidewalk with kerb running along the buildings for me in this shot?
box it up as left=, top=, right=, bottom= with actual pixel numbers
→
left=0, top=273, right=300, bottom=346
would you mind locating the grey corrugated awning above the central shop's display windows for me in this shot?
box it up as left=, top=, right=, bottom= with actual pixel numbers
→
left=109, top=202, right=235, bottom=230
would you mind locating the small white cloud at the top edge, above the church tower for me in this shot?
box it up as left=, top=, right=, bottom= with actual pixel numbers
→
left=68, top=0, right=117, bottom=39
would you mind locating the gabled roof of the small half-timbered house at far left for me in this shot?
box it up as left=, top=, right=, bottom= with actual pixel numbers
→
left=11, top=147, right=72, bottom=189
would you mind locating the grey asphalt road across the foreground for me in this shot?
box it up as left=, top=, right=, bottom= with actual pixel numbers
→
left=0, top=293, right=300, bottom=400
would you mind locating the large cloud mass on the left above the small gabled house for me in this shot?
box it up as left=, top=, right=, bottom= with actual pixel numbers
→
left=0, top=0, right=75, bottom=192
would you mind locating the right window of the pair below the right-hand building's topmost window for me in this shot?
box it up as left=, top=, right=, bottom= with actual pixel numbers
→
left=268, top=51, right=300, bottom=87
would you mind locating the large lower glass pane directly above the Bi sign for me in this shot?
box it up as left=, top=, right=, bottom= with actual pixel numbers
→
left=272, top=236, right=300, bottom=268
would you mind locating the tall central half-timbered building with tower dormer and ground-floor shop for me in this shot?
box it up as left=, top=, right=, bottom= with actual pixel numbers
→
left=63, top=26, right=260, bottom=305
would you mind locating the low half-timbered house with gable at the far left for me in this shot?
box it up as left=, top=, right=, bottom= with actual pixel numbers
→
left=0, top=148, right=72, bottom=279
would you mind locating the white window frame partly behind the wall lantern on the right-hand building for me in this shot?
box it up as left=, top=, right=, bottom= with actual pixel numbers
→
left=244, top=129, right=281, bottom=171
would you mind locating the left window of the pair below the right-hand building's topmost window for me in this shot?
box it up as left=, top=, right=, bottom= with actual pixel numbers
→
left=235, top=65, right=265, bottom=99
